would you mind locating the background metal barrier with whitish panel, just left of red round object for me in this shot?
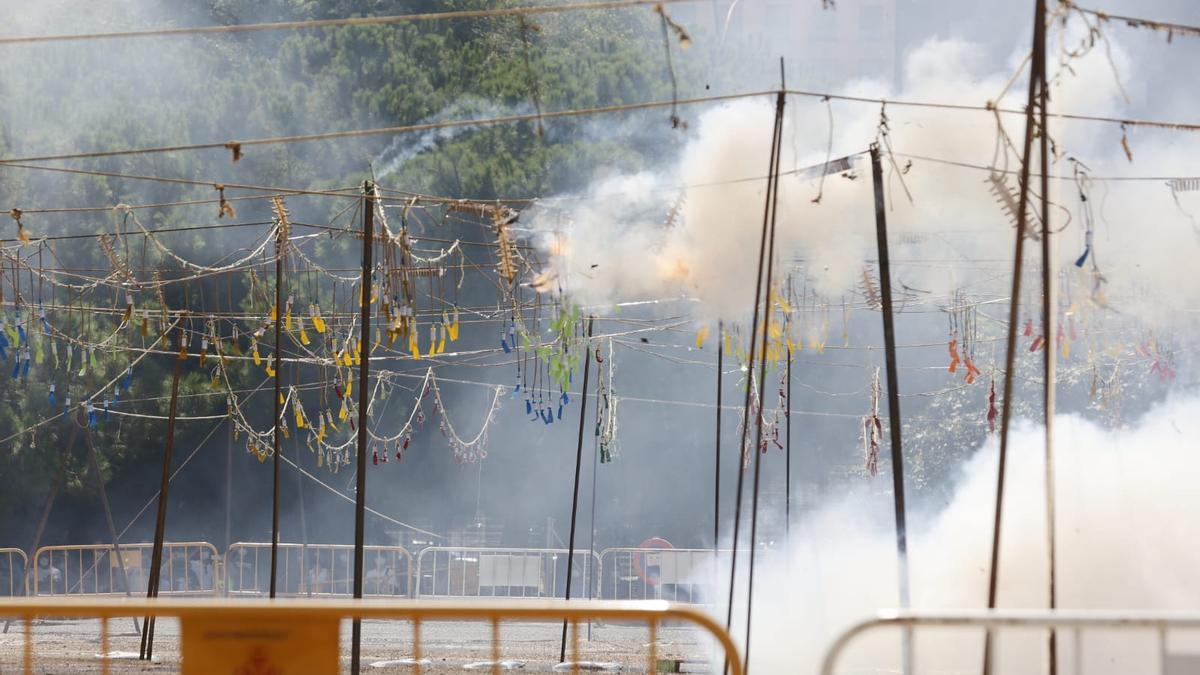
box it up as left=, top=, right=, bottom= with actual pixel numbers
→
left=414, top=546, right=600, bottom=598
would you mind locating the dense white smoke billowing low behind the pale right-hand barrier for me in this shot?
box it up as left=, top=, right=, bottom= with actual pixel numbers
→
left=720, top=394, right=1200, bottom=674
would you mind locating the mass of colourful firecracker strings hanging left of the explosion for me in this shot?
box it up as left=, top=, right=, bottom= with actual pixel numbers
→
left=0, top=191, right=595, bottom=472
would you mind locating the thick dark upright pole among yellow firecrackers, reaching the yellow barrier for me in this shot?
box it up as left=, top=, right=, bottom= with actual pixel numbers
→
left=350, top=180, right=372, bottom=675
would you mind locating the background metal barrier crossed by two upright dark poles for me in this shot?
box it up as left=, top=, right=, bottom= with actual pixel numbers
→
left=224, top=542, right=413, bottom=598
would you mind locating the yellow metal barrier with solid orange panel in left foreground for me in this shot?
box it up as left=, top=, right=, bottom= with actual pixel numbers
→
left=0, top=597, right=743, bottom=675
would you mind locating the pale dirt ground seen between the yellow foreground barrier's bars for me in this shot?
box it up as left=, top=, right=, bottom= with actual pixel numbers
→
left=0, top=619, right=712, bottom=675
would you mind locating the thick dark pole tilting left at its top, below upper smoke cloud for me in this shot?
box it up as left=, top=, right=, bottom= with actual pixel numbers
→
left=871, top=144, right=912, bottom=673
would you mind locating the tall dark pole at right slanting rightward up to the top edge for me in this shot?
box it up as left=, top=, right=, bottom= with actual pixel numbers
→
left=983, top=0, right=1051, bottom=675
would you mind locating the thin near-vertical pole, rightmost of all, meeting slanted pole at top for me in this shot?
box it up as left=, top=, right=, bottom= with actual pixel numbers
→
left=1037, top=0, right=1058, bottom=662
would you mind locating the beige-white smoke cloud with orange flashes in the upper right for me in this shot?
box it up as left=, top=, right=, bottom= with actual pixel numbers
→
left=528, top=35, right=1200, bottom=319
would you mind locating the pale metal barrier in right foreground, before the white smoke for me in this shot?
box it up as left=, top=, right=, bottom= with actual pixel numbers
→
left=821, top=610, right=1200, bottom=675
